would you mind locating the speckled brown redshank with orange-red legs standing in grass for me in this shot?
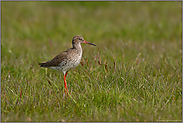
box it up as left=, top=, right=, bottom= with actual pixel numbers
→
left=39, top=35, right=96, bottom=92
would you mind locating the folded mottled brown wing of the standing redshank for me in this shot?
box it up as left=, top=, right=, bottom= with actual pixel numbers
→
left=39, top=51, right=68, bottom=67
